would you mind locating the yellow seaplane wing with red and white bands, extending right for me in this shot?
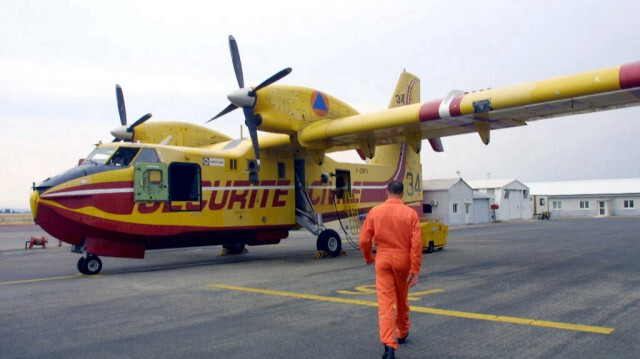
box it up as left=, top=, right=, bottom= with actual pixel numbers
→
left=298, top=62, right=640, bottom=151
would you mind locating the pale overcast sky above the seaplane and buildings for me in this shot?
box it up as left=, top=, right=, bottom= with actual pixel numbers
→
left=0, top=0, right=640, bottom=208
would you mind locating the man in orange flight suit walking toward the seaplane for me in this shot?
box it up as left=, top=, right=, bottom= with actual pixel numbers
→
left=359, top=181, right=422, bottom=359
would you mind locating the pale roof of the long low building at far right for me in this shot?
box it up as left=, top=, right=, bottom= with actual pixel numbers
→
left=527, top=178, right=640, bottom=196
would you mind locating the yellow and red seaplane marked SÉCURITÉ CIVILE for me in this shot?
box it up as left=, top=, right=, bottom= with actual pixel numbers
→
left=31, top=36, right=640, bottom=274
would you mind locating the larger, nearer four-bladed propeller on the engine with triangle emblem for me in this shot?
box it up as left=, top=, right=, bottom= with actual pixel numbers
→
left=206, top=35, right=291, bottom=165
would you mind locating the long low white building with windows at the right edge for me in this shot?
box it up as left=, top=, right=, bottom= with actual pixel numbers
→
left=527, top=178, right=640, bottom=217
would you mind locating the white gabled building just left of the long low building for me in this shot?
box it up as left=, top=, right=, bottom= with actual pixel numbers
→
left=467, top=179, right=533, bottom=221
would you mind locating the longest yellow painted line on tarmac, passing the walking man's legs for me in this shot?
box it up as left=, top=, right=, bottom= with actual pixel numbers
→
left=208, top=284, right=615, bottom=335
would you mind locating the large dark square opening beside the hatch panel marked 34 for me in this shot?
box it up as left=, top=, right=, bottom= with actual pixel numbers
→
left=169, top=162, right=202, bottom=202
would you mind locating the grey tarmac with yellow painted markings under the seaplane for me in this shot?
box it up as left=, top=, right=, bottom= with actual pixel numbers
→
left=0, top=217, right=640, bottom=358
